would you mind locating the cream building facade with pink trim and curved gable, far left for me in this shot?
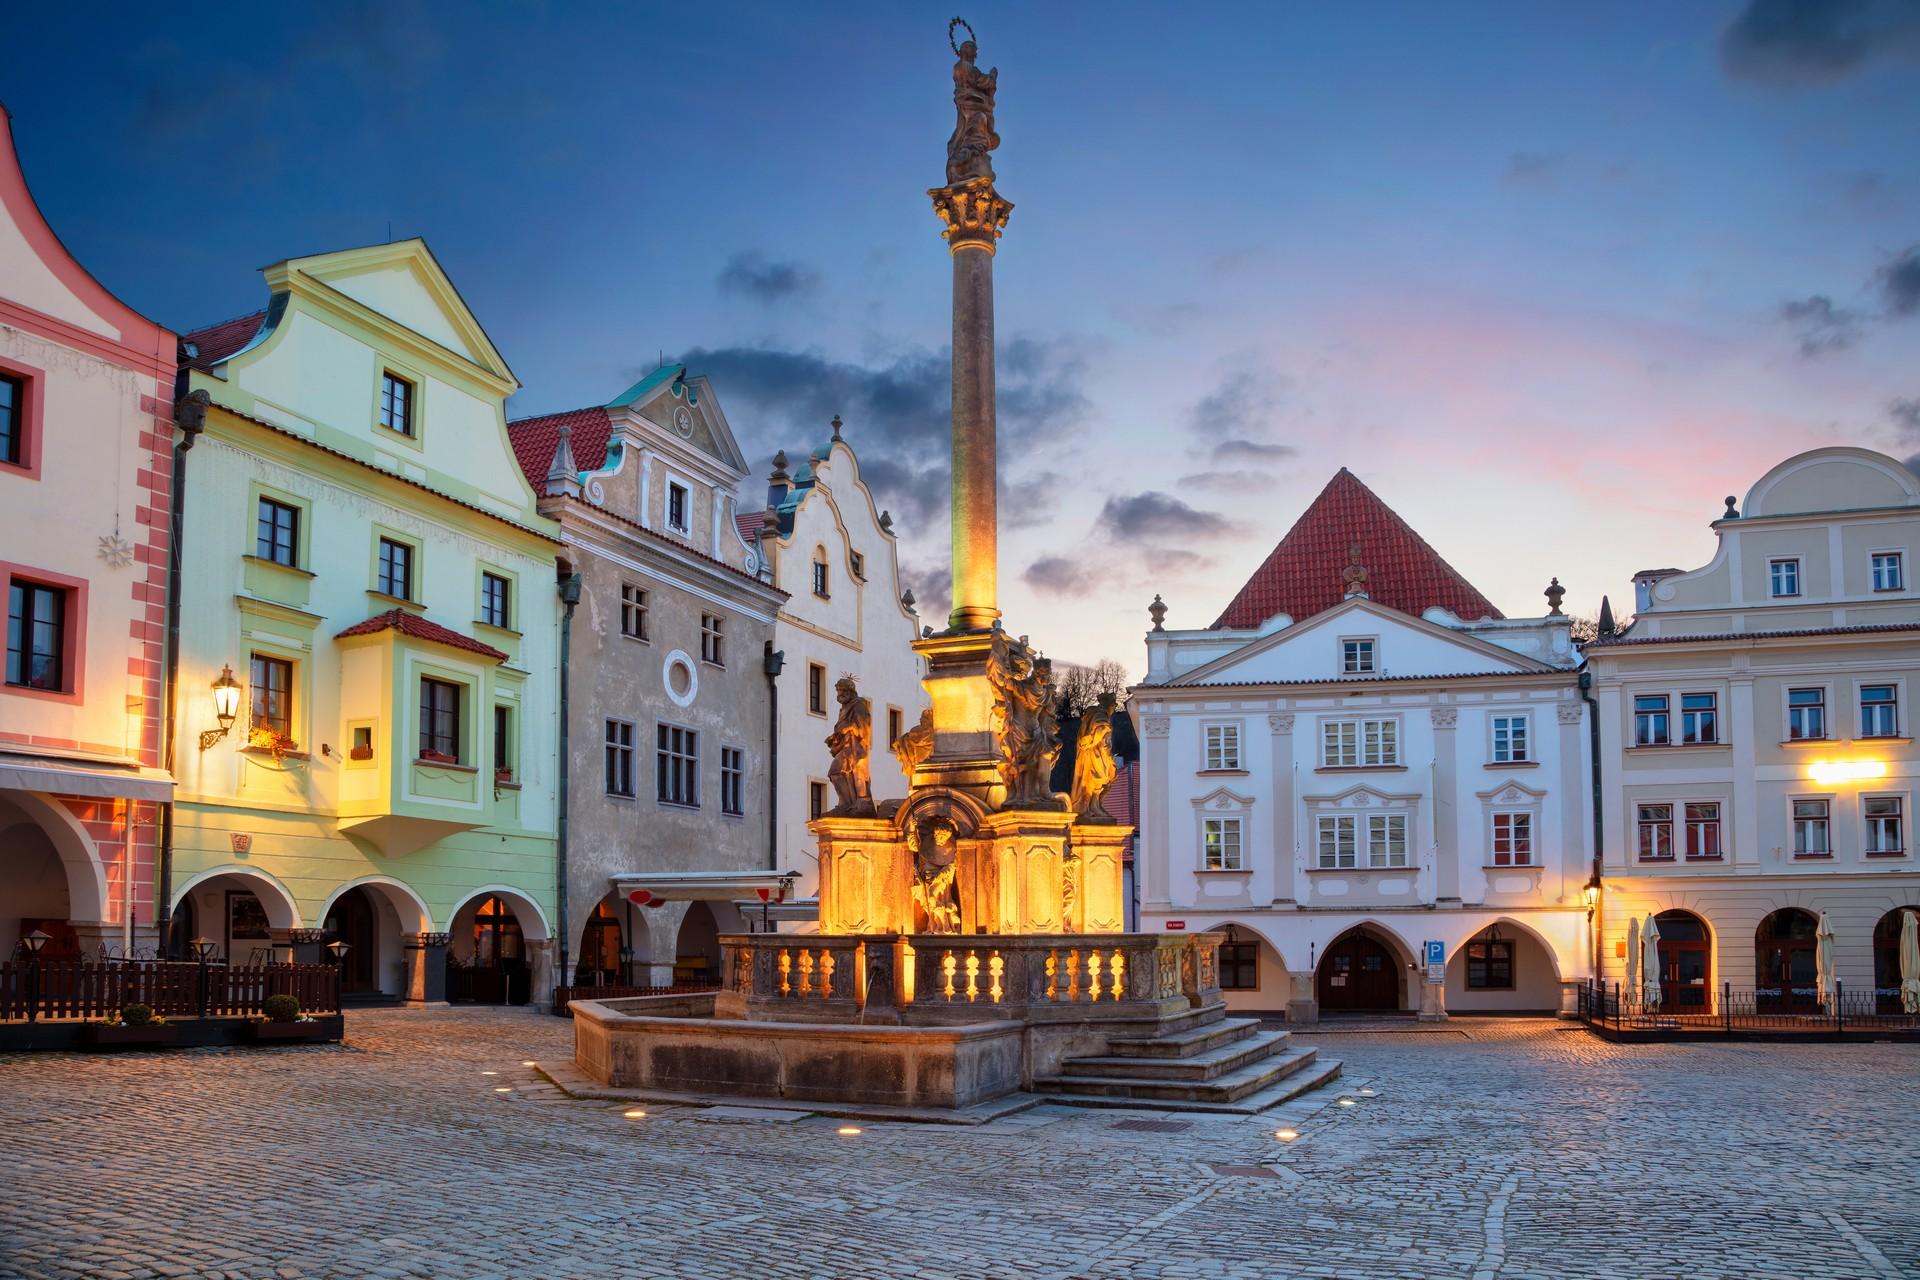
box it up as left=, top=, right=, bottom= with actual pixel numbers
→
left=0, top=107, right=177, bottom=958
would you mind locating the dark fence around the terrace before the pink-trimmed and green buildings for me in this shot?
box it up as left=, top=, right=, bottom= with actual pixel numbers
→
left=0, top=960, right=340, bottom=1023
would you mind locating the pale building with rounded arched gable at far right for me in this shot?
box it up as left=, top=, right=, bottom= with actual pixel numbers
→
left=1586, top=447, right=1920, bottom=1011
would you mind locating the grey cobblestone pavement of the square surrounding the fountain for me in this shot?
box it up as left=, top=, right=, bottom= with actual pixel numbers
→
left=0, top=1009, right=1920, bottom=1280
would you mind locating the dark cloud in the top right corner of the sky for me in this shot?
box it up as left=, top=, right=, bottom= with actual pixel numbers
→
left=1720, top=0, right=1920, bottom=88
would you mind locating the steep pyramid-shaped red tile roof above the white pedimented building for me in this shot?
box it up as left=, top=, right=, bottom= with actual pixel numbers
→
left=1213, top=466, right=1501, bottom=629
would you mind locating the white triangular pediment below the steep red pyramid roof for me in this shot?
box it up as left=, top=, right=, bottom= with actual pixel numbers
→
left=1171, top=597, right=1553, bottom=685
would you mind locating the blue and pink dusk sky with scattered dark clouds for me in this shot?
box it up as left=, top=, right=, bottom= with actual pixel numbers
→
left=0, top=0, right=1920, bottom=676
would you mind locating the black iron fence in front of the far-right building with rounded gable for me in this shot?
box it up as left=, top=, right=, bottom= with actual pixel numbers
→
left=1576, top=983, right=1920, bottom=1036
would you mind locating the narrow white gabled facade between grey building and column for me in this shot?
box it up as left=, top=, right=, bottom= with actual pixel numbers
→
left=743, top=429, right=927, bottom=927
